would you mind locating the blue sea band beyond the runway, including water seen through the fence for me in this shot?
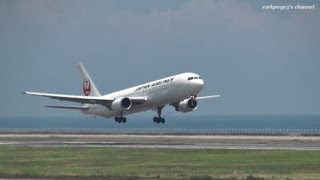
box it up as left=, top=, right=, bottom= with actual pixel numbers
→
left=0, top=115, right=320, bottom=135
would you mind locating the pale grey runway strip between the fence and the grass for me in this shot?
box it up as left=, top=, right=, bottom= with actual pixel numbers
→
left=0, top=134, right=320, bottom=150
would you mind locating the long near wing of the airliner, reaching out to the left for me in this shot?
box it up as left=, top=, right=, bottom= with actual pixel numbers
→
left=23, top=92, right=147, bottom=106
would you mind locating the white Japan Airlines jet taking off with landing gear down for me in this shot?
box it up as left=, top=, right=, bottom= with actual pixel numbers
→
left=24, top=63, right=219, bottom=123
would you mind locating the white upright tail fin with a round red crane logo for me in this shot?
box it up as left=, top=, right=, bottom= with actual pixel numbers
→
left=78, top=63, right=101, bottom=96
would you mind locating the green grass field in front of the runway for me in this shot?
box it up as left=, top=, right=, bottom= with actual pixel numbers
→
left=0, top=147, right=320, bottom=179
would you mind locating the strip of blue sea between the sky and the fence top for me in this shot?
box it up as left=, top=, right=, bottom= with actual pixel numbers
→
left=0, top=115, right=320, bottom=129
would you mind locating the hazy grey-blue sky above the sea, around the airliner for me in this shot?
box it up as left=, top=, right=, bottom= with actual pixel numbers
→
left=0, top=0, right=320, bottom=117
